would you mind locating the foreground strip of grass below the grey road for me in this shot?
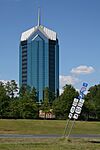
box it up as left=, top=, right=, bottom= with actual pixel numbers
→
left=0, top=139, right=100, bottom=150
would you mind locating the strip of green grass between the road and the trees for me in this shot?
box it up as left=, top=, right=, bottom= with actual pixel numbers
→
left=0, top=120, right=100, bottom=135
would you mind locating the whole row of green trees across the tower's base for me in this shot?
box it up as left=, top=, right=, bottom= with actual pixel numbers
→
left=0, top=80, right=100, bottom=120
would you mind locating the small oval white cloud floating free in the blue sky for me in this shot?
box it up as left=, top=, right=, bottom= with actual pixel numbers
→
left=71, top=65, right=95, bottom=75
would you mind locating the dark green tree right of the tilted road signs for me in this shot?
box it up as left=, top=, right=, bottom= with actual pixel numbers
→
left=83, top=84, right=100, bottom=120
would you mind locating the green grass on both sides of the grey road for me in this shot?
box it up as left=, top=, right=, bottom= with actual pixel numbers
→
left=0, top=120, right=100, bottom=150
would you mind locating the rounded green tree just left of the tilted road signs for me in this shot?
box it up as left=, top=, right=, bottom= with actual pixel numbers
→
left=53, top=85, right=78, bottom=119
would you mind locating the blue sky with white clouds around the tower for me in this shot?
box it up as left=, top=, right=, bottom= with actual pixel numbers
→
left=0, top=0, right=100, bottom=92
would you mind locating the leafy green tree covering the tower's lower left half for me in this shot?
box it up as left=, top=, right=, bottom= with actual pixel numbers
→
left=19, top=86, right=38, bottom=119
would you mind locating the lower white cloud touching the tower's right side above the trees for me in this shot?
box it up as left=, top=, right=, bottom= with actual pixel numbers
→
left=60, top=75, right=80, bottom=88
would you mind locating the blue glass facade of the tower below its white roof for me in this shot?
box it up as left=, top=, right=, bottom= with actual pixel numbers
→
left=19, top=26, right=59, bottom=102
